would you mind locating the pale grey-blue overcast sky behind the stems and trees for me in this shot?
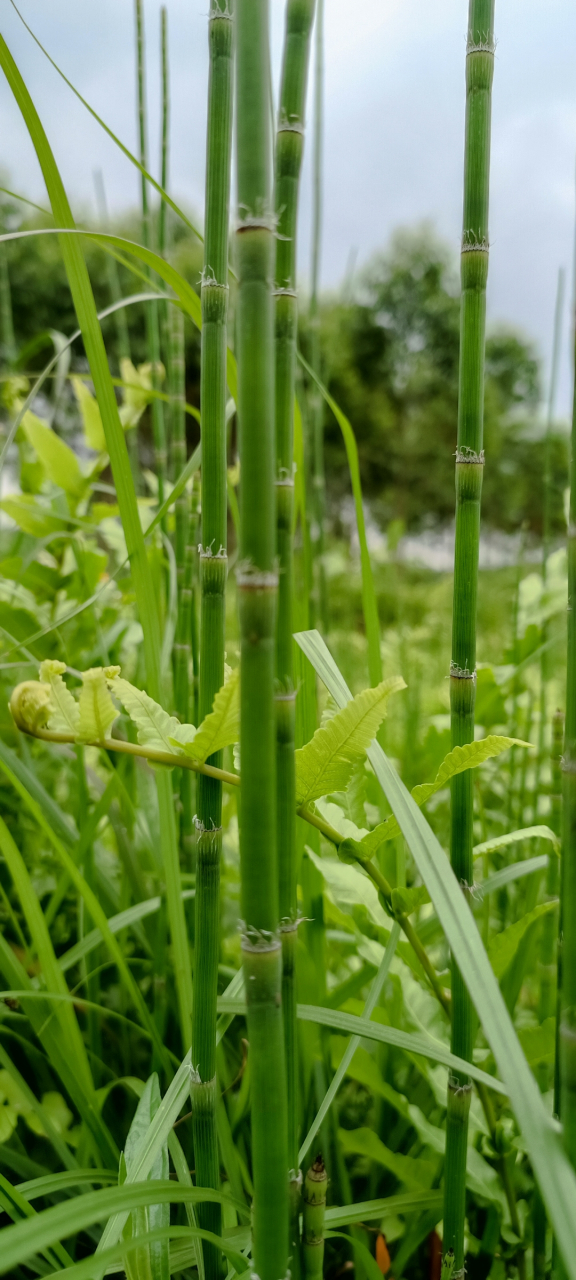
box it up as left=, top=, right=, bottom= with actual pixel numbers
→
left=0, top=0, right=576, bottom=416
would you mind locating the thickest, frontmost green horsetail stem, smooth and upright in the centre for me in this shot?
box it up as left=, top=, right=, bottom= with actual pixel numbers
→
left=236, top=0, right=288, bottom=1280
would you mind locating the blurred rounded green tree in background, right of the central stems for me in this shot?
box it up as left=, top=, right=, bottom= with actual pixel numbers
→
left=302, top=225, right=567, bottom=534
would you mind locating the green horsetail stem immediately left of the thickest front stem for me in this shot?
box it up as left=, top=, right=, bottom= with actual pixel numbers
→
left=192, top=0, right=233, bottom=1280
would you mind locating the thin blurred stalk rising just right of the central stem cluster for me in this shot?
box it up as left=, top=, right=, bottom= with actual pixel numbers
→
left=310, top=0, right=328, bottom=631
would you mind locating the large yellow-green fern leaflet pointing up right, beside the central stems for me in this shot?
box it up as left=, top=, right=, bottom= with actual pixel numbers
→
left=296, top=676, right=406, bottom=808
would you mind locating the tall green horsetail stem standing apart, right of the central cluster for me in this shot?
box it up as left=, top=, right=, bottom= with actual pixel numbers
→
left=444, top=0, right=494, bottom=1277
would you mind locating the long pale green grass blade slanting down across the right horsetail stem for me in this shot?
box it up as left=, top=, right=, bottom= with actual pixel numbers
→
left=296, top=631, right=576, bottom=1280
